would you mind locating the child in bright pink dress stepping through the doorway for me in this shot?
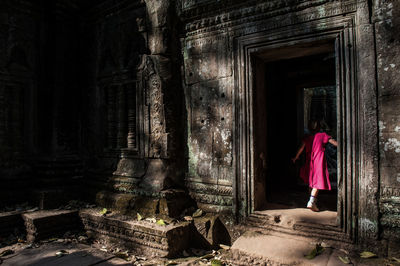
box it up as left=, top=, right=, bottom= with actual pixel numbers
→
left=292, top=121, right=337, bottom=212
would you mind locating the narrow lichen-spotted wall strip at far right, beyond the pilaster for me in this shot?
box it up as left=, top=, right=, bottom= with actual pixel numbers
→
left=373, top=0, right=400, bottom=254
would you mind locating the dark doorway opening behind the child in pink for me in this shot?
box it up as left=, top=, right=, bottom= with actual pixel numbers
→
left=253, top=42, right=337, bottom=211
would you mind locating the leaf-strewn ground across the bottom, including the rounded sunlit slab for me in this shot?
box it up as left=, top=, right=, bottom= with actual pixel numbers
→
left=0, top=235, right=400, bottom=266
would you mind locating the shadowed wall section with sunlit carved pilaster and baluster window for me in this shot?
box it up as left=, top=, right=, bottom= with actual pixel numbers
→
left=81, top=1, right=189, bottom=215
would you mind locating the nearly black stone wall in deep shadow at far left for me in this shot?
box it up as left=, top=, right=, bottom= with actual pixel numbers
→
left=0, top=1, right=82, bottom=204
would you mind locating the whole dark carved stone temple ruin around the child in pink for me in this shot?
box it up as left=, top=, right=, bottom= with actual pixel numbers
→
left=0, top=0, right=400, bottom=262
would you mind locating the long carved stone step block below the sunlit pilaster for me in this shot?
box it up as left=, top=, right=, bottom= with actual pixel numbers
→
left=79, top=209, right=193, bottom=257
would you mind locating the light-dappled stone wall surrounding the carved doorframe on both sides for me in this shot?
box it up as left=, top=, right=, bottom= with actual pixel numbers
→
left=181, top=0, right=400, bottom=252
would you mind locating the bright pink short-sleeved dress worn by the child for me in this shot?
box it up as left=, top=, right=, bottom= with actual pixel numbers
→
left=300, top=133, right=331, bottom=190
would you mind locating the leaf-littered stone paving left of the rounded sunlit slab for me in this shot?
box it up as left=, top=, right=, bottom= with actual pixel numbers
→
left=0, top=239, right=229, bottom=266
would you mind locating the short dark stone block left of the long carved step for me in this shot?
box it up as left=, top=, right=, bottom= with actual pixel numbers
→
left=22, top=210, right=82, bottom=242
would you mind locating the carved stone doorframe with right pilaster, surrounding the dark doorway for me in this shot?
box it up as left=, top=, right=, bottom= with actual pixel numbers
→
left=233, top=9, right=378, bottom=241
